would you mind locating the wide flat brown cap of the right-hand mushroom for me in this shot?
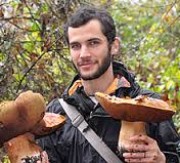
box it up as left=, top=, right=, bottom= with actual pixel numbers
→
left=95, top=92, right=175, bottom=122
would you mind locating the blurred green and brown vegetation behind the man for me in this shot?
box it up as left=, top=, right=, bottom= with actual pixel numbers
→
left=0, top=0, right=180, bottom=162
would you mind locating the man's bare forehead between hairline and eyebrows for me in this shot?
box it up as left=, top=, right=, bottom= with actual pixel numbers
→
left=68, top=20, right=106, bottom=43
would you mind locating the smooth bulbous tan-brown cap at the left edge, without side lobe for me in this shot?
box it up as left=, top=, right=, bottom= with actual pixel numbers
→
left=0, top=91, right=46, bottom=146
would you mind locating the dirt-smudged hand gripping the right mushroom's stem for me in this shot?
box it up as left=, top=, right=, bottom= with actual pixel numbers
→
left=123, top=135, right=166, bottom=163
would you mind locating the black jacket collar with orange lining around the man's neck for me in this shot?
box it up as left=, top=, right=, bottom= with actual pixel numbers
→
left=62, top=62, right=140, bottom=117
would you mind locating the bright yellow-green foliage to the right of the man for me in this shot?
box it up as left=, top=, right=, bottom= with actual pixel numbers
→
left=111, top=1, right=180, bottom=132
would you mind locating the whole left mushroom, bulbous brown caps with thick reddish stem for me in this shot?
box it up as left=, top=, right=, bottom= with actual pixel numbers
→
left=0, top=91, right=66, bottom=163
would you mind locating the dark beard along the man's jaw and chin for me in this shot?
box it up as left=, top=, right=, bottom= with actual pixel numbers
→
left=73, top=53, right=112, bottom=81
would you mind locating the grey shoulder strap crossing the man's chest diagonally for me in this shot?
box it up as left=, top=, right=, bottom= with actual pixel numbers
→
left=59, top=99, right=123, bottom=163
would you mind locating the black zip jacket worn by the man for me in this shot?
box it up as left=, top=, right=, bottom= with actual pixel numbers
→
left=38, top=62, right=180, bottom=163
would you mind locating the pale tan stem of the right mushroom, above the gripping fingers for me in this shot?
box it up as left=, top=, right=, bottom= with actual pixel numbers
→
left=118, top=120, right=146, bottom=153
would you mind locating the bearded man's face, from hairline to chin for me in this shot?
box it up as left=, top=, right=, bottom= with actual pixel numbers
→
left=68, top=20, right=112, bottom=80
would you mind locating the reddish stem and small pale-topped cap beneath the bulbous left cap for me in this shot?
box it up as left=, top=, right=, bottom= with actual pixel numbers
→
left=4, top=113, right=65, bottom=163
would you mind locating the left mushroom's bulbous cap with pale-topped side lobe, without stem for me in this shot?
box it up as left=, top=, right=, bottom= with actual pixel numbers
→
left=0, top=91, right=65, bottom=147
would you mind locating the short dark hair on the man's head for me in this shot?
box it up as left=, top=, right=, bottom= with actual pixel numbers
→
left=64, top=6, right=116, bottom=44
